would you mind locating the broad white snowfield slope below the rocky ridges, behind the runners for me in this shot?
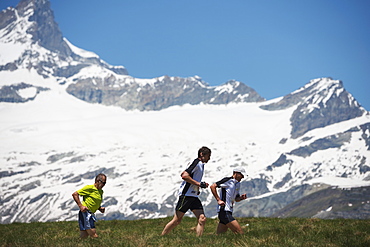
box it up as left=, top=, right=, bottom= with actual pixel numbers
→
left=0, top=86, right=370, bottom=223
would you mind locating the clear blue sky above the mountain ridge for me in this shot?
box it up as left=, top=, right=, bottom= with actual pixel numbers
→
left=0, top=0, right=370, bottom=110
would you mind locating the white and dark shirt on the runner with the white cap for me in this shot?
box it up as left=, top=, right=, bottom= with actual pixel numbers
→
left=216, top=177, right=240, bottom=212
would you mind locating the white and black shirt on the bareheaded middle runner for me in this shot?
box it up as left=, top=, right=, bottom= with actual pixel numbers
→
left=179, top=158, right=204, bottom=197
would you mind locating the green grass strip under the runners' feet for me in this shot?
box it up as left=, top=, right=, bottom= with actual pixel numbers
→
left=0, top=218, right=370, bottom=247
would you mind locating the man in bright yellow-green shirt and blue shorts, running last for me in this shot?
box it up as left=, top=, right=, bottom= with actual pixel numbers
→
left=72, top=173, right=107, bottom=238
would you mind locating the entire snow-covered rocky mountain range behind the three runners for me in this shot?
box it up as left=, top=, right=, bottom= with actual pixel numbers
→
left=0, top=0, right=370, bottom=223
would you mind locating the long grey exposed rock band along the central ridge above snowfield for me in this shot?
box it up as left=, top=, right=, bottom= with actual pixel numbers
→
left=67, top=75, right=264, bottom=111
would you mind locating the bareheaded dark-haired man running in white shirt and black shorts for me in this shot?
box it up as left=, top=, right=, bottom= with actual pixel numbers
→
left=162, top=147, right=211, bottom=236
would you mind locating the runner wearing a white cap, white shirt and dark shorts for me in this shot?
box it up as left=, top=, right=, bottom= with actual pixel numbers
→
left=211, top=167, right=247, bottom=234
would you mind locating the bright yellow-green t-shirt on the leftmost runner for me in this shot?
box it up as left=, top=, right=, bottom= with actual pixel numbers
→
left=77, top=185, right=103, bottom=213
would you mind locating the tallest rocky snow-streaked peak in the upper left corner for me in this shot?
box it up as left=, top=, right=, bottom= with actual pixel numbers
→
left=0, top=0, right=128, bottom=80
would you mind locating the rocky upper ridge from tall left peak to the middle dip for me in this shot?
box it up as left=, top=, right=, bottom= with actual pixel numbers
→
left=0, top=0, right=264, bottom=110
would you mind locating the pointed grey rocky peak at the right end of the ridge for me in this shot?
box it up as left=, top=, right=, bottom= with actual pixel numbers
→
left=261, top=77, right=367, bottom=138
